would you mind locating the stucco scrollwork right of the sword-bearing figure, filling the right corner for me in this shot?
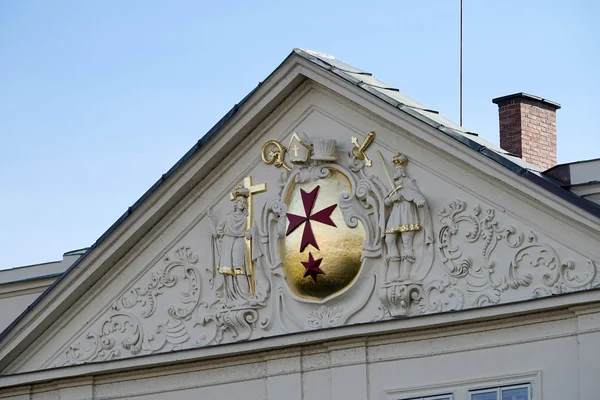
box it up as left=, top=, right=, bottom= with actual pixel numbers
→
left=432, top=200, right=597, bottom=311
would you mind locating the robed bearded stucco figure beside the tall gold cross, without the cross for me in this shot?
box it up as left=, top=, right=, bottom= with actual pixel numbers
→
left=209, top=186, right=260, bottom=307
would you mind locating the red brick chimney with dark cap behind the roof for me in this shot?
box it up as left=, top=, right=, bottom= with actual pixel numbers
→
left=492, top=93, right=560, bottom=171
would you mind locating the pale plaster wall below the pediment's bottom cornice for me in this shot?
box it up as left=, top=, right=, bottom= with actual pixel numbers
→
left=0, top=310, right=600, bottom=400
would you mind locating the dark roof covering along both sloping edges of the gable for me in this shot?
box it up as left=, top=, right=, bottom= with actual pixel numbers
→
left=0, top=49, right=600, bottom=341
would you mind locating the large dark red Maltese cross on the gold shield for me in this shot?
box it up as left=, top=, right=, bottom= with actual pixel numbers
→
left=285, top=186, right=337, bottom=253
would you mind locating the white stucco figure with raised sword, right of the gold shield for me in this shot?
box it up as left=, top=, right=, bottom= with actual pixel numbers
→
left=384, top=154, right=433, bottom=282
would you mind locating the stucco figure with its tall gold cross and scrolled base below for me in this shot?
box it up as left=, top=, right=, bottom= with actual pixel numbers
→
left=197, top=177, right=280, bottom=345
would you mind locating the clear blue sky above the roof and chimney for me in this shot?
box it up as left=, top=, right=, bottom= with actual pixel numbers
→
left=0, top=0, right=600, bottom=269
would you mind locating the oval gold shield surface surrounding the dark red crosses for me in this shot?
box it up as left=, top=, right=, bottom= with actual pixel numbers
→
left=280, top=170, right=365, bottom=300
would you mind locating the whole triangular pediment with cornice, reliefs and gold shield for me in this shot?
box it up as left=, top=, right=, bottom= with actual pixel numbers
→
left=0, top=53, right=600, bottom=374
